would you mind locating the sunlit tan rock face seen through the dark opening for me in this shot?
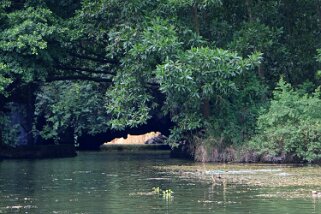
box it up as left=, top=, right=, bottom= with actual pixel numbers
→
left=105, top=132, right=166, bottom=145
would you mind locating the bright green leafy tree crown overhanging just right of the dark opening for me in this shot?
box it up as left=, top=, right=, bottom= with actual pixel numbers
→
left=156, top=48, right=261, bottom=144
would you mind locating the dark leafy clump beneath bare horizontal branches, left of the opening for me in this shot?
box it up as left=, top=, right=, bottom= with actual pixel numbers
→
left=35, top=82, right=109, bottom=141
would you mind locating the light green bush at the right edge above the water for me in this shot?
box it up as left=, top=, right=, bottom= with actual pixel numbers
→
left=250, top=79, right=321, bottom=162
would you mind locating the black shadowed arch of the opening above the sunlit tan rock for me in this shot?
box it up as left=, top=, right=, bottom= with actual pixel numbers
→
left=78, top=117, right=174, bottom=150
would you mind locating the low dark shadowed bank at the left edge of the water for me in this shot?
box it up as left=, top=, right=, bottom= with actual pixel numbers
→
left=0, top=144, right=77, bottom=159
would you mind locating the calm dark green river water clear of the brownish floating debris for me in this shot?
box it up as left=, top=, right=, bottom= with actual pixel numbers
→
left=0, top=152, right=321, bottom=214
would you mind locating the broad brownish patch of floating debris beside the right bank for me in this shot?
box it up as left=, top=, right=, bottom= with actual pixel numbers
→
left=155, top=163, right=321, bottom=188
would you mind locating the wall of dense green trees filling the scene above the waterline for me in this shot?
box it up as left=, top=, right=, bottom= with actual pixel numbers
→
left=0, top=0, right=321, bottom=160
